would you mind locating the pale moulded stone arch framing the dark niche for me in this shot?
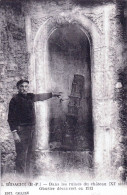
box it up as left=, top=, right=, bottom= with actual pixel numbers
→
left=31, top=12, right=117, bottom=177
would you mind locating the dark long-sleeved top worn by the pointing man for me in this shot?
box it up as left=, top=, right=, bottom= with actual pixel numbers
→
left=8, top=93, right=52, bottom=131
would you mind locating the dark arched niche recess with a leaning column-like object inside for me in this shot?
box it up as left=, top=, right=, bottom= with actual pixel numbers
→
left=48, top=23, right=94, bottom=151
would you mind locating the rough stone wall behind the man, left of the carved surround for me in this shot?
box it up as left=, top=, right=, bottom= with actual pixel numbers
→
left=0, top=3, right=28, bottom=173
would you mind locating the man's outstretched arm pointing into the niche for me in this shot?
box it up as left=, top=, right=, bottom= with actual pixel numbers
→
left=34, top=93, right=61, bottom=102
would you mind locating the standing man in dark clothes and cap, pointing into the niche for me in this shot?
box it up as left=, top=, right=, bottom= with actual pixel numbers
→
left=8, top=80, right=60, bottom=173
